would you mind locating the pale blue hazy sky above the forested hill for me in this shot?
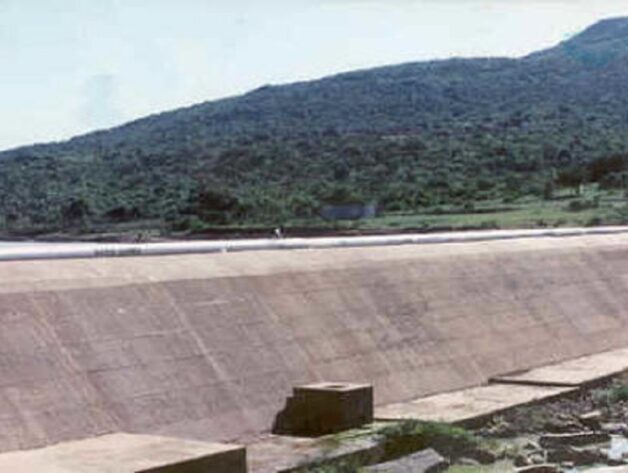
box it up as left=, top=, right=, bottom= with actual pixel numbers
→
left=0, top=0, right=628, bottom=150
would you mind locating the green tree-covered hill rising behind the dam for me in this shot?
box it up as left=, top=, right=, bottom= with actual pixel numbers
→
left=0, top=18, right=628, bottom=232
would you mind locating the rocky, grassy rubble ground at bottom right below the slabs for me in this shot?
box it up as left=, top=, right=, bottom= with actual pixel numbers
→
left=291, top=373, right=628, bottom=473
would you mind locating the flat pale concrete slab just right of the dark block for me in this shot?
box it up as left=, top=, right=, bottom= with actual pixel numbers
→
left=375, top=384, right=575, bottom=425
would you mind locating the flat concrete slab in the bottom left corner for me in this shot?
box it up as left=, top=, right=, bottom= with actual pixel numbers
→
left=0, top=434, right=247, bottom=473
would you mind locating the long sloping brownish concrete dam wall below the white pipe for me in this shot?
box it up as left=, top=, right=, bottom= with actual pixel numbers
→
left=0, top=235, right=628, bottom=451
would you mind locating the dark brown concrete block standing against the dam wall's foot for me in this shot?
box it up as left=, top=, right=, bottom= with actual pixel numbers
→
left=273, top=383, right=373, bottom=436
